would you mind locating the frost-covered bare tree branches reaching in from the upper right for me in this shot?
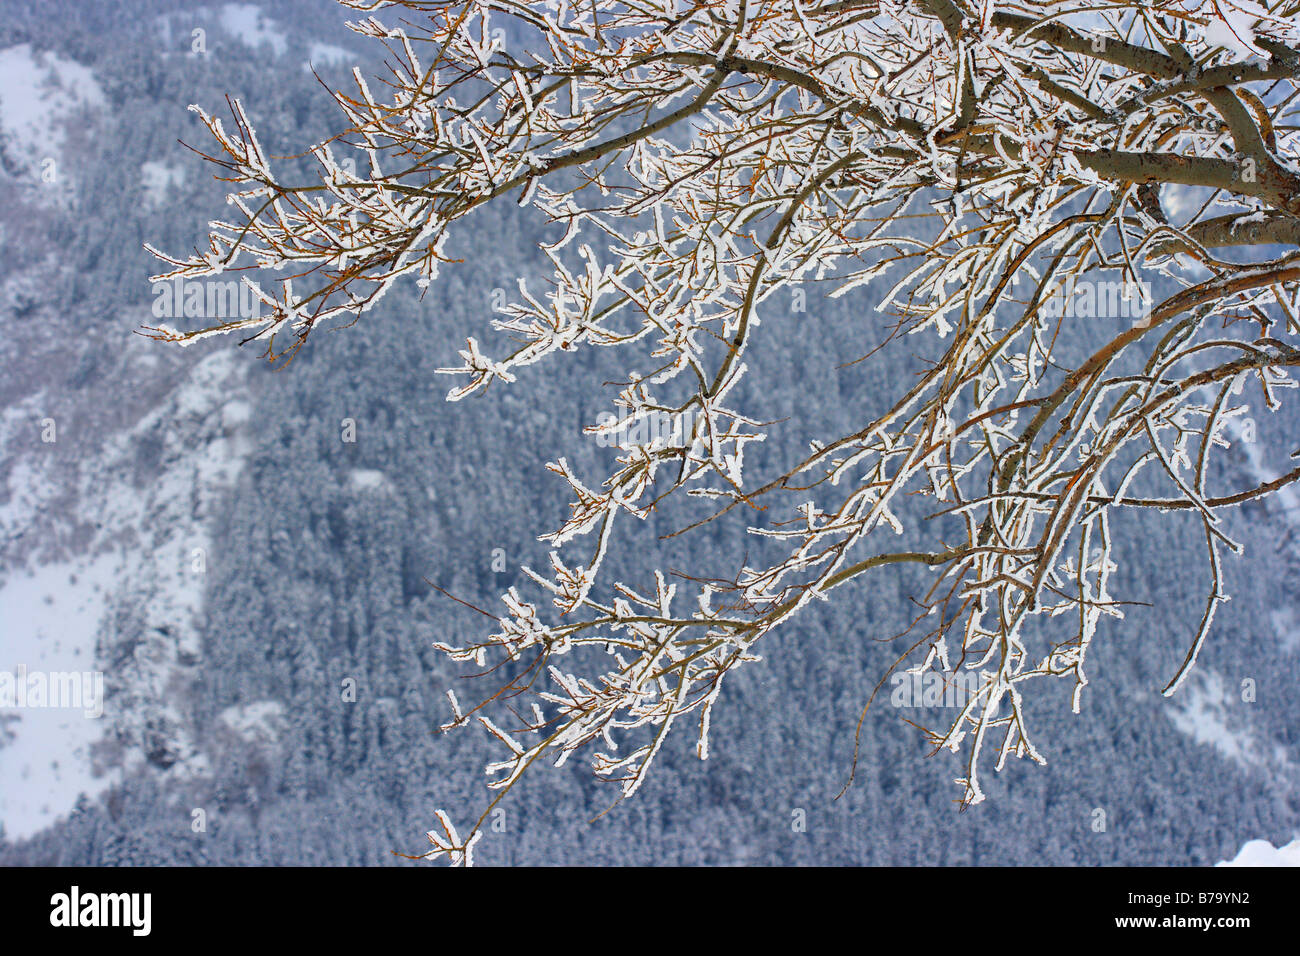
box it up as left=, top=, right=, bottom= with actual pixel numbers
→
left=152, top=0, right=1300, bottom=862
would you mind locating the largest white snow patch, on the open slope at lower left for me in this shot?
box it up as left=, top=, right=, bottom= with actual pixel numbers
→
left=0, top=352, right=256, bottom=839
